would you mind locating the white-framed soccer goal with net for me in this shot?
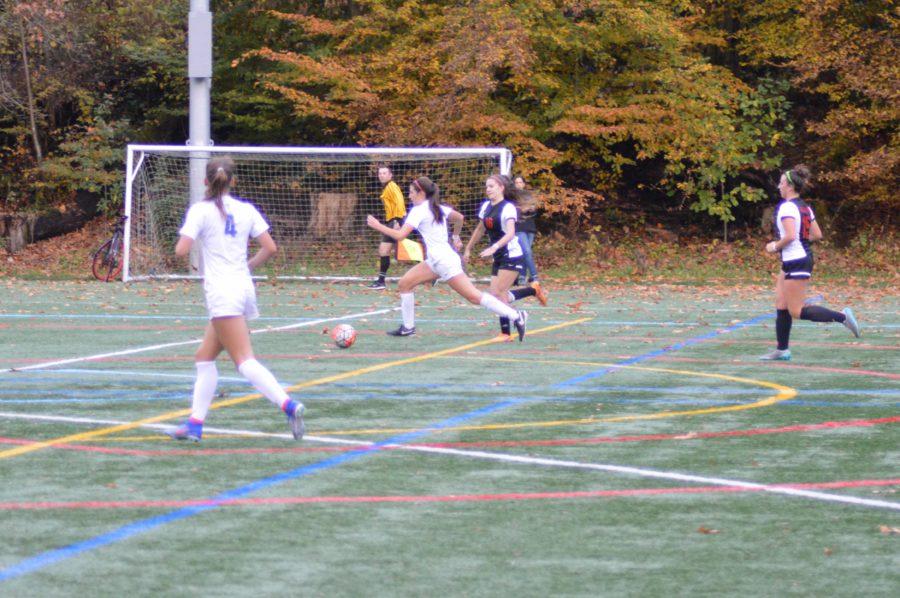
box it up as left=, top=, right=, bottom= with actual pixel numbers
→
left=122, top=145, right=512, bottom=281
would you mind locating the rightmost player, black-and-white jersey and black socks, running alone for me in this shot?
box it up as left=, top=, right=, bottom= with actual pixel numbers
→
left=760, top=165, right=859, bottom=361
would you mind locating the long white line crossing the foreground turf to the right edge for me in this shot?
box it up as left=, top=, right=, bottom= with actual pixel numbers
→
left=0, top=412, right=900, bottom=511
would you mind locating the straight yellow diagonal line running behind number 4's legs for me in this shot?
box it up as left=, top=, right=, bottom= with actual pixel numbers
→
left=0, top=318, right=592, bottom=459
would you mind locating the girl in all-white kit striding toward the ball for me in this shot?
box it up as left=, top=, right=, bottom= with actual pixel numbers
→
left=366, top=176, right=528, bottom=341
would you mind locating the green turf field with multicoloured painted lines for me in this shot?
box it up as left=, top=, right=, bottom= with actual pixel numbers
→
left=0, top=281, right=900, bottom=596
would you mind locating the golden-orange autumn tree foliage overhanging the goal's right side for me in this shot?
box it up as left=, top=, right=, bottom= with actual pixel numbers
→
left=236, top=0, right=784, bottom=227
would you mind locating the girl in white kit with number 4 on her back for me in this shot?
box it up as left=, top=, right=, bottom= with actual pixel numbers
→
left=168, top=158, right=304, bottom=442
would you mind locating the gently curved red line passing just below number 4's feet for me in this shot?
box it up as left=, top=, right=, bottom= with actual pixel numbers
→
left=0, top=416, right=900, bottom=457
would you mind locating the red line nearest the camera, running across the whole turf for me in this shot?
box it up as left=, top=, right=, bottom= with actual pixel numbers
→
left=0, top=478, right=900, bottom=511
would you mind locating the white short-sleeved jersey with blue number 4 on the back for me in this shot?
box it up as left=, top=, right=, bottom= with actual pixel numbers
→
left=179, top=195, right=269, bottom=284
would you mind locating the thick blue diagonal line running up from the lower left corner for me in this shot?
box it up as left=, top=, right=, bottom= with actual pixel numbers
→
left=0, top=314, right=775, bottom=582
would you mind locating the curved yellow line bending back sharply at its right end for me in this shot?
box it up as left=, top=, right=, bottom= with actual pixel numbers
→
left=318, top=356, right=797, bottom=436
